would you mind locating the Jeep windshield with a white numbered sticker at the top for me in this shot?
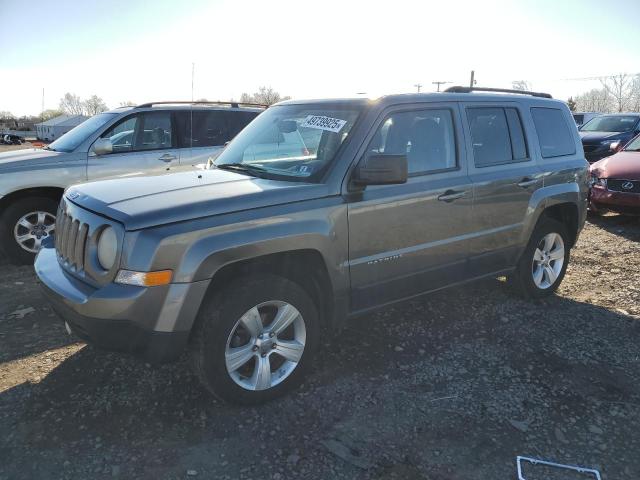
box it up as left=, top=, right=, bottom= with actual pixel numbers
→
left=215, top=104, right=360, bottom=181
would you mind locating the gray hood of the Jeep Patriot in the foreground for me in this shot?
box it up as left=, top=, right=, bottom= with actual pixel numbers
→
left=66, top=169, right=328, bottom=230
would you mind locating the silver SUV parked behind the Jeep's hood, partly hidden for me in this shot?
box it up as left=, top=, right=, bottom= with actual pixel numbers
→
left=0, top=102, right=263, bottom=263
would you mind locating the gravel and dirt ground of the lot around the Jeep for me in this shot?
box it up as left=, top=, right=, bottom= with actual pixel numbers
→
left=0, top=216, right=640, bottom=480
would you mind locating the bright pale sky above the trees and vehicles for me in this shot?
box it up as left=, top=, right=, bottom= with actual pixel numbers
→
left=0, top=0, right=640, bottom=115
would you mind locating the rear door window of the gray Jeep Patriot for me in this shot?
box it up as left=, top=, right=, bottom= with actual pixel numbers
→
left=467, top=107, right=528, bottom=168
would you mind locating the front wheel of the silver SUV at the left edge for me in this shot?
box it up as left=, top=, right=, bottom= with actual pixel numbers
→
left=0, top=197, right=58, bottom=265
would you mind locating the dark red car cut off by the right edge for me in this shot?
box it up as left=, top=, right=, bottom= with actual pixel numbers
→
left=589, top=135, right=640, bottom=215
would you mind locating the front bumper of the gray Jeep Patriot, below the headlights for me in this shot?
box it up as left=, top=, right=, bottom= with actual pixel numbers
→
left=35, top=248, right=208, bottom=362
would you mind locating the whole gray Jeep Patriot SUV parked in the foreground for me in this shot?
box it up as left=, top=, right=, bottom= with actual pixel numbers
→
left=35, top=88, right=588, bottom=404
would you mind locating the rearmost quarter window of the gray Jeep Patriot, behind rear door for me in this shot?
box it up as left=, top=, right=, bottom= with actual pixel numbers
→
left=531, top=107, right=576, bottom=158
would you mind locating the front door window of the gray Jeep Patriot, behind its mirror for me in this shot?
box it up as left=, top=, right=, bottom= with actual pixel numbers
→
left=368, top=109, right=456, bottom=175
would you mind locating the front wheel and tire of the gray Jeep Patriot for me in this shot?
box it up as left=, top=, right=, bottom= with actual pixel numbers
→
left=191, top=274, right=319, bottom=405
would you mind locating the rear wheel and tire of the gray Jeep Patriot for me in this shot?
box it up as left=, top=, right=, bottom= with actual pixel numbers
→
left=509, top=217, right=570, bottom=298
